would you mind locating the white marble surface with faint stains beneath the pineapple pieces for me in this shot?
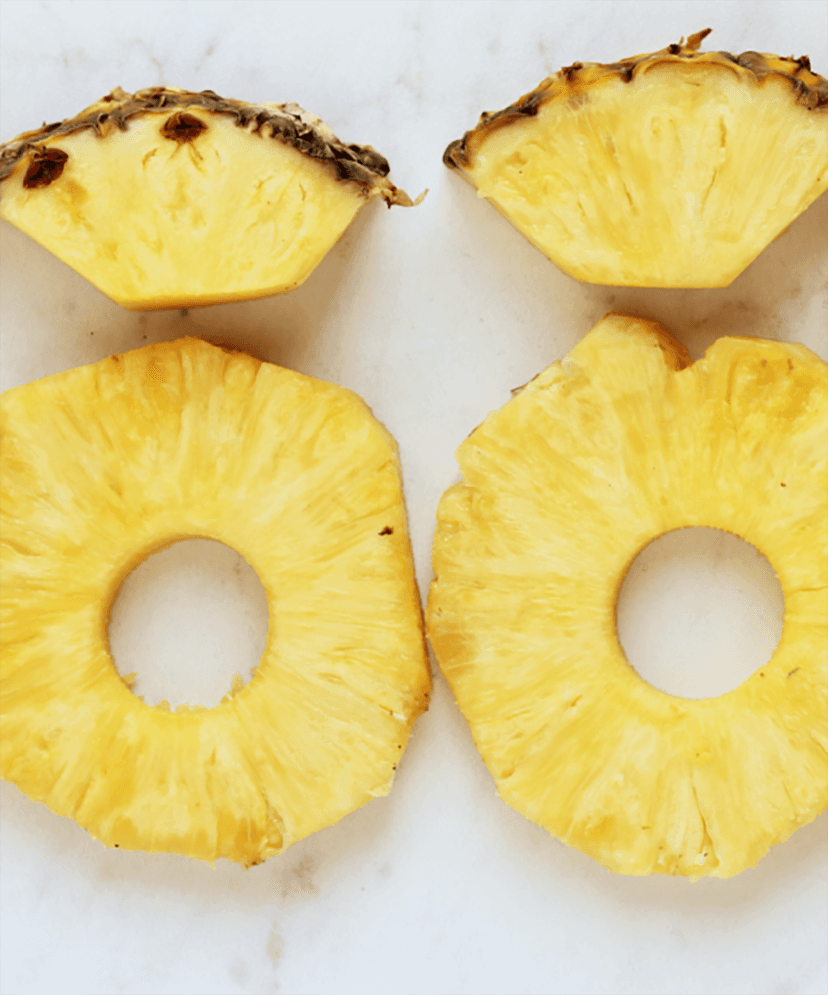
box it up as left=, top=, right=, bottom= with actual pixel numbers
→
left=0, top=0, right=828, bottom=995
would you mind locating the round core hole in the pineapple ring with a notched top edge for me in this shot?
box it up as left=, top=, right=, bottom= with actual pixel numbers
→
left=616, top=528, right=785, bottom=698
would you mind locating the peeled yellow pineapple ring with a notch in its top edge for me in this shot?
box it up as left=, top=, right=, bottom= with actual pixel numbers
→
left=426, top=314, right=828, bottom=877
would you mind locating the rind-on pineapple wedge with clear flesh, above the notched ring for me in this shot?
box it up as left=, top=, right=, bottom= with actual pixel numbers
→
left=443, top=31, right=828, bottom=287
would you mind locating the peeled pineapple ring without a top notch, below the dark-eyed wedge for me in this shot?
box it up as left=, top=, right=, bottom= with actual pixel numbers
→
left=0, top=339, right=430, bottom=866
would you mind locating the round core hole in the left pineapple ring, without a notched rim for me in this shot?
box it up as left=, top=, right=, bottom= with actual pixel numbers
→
left=109, top=539, right=268, bottom=708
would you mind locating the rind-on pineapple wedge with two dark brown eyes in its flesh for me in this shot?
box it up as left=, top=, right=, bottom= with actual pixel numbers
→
left=0, top=87, right=411, bottom=310
